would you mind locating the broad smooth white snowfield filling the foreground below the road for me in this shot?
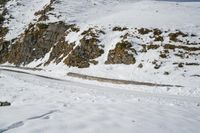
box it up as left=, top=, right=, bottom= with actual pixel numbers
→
left=0, top=70, right=200, bottom=133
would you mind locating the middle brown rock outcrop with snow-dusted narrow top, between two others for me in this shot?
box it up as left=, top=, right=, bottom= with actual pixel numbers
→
left=64, top=28, right=104, bottom=68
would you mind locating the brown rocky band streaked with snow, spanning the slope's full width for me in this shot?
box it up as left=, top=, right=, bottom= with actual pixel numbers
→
left=0, top=21, right=200, bottom=69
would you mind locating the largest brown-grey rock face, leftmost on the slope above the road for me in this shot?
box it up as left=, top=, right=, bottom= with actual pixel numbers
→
left=0, top=22, right=67, bottom=65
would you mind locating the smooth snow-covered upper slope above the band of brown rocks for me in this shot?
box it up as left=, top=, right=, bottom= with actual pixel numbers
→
left=3, top=0, right=200, bottom=39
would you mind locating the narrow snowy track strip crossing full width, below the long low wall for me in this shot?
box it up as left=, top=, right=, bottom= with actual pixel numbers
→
left=0, top=68, right=200, bottom=104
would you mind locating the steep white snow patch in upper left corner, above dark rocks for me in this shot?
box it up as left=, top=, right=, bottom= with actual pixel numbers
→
left=5, top=0, right=50, bottom=40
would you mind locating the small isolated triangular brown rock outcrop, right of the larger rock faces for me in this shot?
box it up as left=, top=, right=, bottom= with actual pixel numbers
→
left=105, top=41, right=136, bottom=65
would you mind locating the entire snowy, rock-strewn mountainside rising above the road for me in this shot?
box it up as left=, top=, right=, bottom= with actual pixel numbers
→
left=0, top=0, right=200, bottom=95
